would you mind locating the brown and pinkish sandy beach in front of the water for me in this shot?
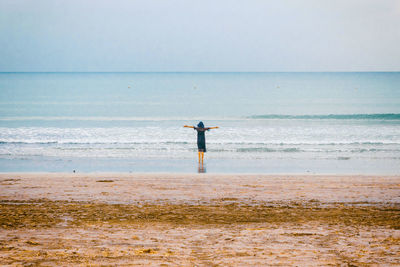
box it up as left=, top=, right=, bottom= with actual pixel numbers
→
left=0, top=173, right=400, bottom=266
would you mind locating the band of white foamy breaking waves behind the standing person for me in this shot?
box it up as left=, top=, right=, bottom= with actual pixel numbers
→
left=0, top=120, right=400, bottom=159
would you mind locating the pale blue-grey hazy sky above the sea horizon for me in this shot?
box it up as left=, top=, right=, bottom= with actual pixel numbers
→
left=0, top=0, right=400, bottom=72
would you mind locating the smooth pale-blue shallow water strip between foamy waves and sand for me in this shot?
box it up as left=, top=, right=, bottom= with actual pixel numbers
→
left=0, top=156, right=400, bottom=175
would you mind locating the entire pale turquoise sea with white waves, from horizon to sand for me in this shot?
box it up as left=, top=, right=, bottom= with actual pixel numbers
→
left=0, top=72, right=400, bottom=174
